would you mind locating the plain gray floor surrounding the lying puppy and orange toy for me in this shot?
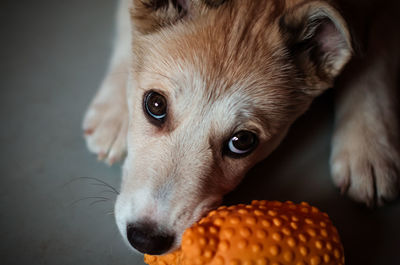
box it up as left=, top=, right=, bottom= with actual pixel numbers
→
left=0, top=0, right=400, bottom=265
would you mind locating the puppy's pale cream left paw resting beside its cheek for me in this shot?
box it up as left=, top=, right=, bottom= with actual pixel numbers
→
left=83, top=86, right=128, bottom=165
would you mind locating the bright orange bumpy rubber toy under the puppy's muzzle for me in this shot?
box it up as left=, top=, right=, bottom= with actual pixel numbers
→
left=145, top=201, right=344, bottom=265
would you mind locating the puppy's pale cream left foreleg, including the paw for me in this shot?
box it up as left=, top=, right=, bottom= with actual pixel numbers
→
left=83, top=0, right=132, bottom=164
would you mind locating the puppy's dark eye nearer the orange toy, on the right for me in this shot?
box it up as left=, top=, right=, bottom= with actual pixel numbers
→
left=227, top=131, right=258, bottom=156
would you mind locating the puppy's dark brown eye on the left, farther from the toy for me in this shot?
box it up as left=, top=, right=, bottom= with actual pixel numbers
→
left=144, top=91, right=167, bottom=122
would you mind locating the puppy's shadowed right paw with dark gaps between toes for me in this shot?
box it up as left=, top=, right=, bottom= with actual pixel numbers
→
left=331, top=124, right=400, bottom=207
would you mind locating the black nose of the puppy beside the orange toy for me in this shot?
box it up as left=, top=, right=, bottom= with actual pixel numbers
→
left=126, top=223, right=175, bottom=255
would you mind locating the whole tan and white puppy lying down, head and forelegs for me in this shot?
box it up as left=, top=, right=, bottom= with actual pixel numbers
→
left=83, top=0, right=400, bottom=255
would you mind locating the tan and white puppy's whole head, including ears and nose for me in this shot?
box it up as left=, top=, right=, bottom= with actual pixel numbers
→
left=115, top=0, right=351, bottom=254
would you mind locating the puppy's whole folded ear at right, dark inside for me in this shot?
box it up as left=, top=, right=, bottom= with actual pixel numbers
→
left=280, top=1, right=352, bottom=95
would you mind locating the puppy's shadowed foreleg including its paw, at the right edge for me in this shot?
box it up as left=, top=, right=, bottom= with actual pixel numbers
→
left=331, top=8, right=400, bottom=206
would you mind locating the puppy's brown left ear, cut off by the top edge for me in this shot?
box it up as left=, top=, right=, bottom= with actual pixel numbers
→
left=131, top=0, right=226, bottom=34
